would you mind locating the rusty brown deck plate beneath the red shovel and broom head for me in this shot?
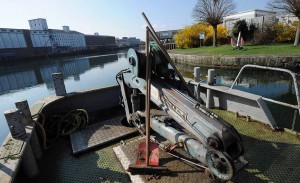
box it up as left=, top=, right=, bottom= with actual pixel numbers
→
left=113, top=138, right=214, bottom=183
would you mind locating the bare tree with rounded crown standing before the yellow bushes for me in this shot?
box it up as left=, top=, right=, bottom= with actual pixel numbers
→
left=193, top=0, right=235, bottom=47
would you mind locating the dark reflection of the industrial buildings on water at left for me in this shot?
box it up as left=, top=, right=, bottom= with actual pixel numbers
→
left=0, top=53, right=119, bottom=94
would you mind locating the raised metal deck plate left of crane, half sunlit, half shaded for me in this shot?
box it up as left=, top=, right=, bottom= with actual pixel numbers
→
left=70, top=116, right=136, bottom=154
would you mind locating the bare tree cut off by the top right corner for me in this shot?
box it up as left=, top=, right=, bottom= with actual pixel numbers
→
left=268, top=0, right=300, bottom=46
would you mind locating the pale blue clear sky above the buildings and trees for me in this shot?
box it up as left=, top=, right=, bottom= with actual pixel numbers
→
left=0, top=0, right=268, bottom=40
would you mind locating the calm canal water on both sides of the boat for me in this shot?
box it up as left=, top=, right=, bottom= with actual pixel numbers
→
left=0, top=50, right=300, bottom=144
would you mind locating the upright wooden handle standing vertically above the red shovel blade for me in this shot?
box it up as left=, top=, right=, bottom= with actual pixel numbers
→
left=145, top=27, right=151, bottom=166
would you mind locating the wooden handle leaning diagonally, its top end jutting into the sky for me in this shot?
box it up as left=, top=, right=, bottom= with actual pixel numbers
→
left=142, top=12, right=195, bottom=98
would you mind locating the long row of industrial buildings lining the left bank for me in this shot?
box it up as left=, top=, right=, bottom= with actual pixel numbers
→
left=0, top=18, right=141, bottom=60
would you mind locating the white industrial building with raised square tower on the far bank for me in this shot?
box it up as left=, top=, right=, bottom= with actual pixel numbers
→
left=29, top=18, right=86, bottom=50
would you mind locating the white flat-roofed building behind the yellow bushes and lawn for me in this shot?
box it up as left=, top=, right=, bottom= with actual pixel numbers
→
left=223, top=9, right=276, bottom=30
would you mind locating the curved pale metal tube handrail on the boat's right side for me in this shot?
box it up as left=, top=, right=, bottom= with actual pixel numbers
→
left=230, top=65, right=300, bottom=114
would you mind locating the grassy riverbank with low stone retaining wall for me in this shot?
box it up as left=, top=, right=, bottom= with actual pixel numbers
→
left=169, top=44, right=300, bottom=69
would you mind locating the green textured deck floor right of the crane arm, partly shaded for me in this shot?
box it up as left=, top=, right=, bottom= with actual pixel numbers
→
left=213, top=109, right=300, bottom=182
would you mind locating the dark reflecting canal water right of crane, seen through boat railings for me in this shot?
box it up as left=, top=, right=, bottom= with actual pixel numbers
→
left=178, top=64, right=300, bottom=131
